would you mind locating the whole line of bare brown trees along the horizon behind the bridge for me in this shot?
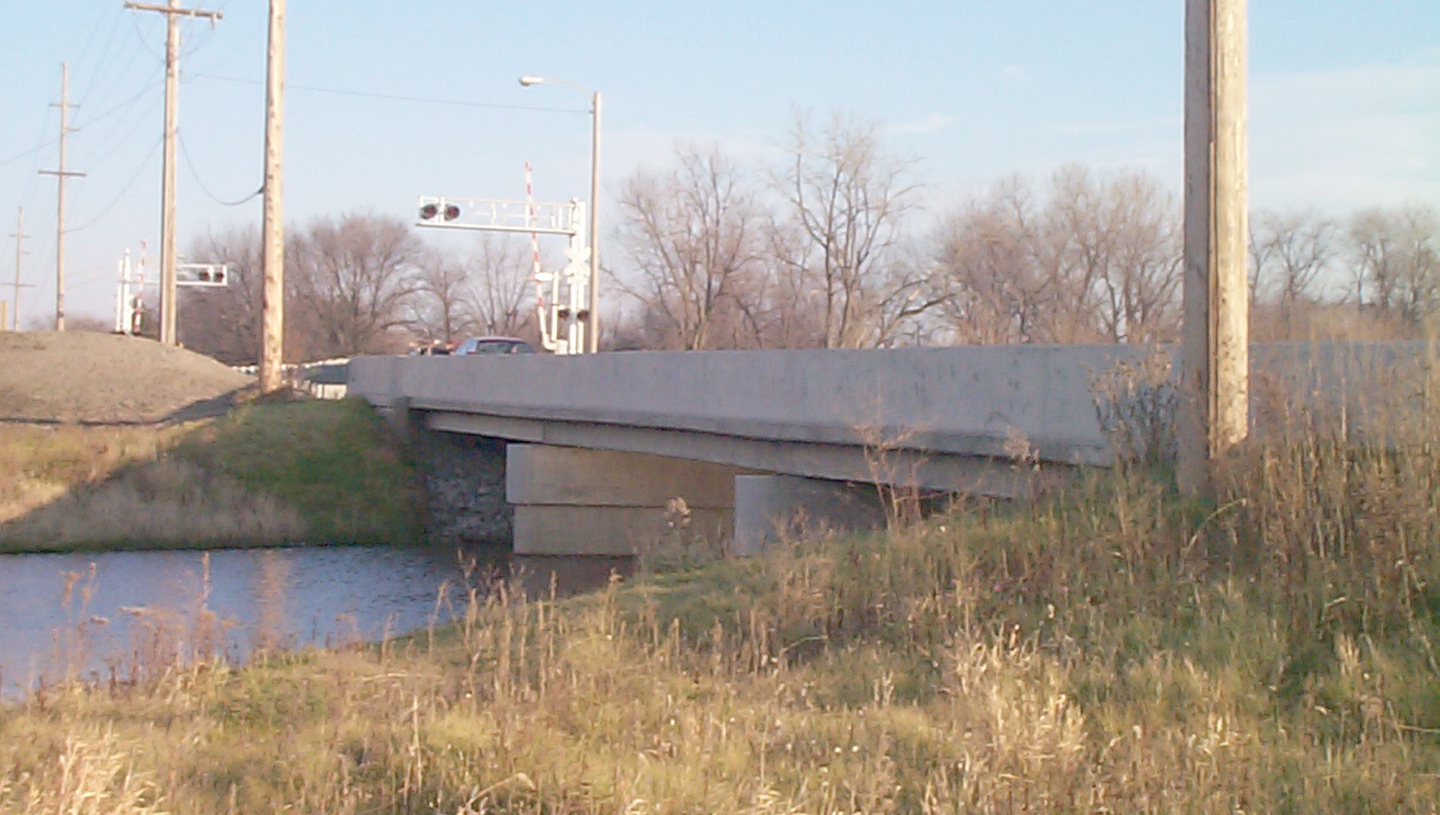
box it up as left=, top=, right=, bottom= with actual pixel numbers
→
left=171, top=114, right=1440, bottom=363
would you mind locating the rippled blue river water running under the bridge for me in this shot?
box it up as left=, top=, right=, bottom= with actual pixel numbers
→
left=0, top=546, right=631, bottom=700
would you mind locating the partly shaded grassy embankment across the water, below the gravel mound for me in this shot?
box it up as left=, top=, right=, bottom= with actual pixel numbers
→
left=0, top=400, right=420, bottom=551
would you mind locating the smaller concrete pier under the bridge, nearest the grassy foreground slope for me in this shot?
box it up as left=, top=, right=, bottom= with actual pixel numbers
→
left=734, top=475, right=886, bottom=554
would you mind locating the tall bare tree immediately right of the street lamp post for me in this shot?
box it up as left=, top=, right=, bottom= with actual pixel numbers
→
left=619, top=145, right=760, bottom=350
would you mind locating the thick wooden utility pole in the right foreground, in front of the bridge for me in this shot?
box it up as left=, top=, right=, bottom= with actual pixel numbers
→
left=1176, top=0, right=1250, bottom=494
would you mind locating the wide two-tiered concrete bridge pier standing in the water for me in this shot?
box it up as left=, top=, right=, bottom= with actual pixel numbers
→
left=505, top=443, right=743, bottom=556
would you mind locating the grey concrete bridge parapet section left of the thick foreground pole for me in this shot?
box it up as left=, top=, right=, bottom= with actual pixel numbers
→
left=350, top=346, right=1146, bottom=465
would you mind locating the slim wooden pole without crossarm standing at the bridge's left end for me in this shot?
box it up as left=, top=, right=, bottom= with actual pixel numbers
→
left=261, top=0, right=285, bottom=393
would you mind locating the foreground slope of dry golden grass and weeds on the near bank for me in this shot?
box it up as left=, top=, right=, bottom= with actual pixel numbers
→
left=0, top=397, right=1440, bottom=814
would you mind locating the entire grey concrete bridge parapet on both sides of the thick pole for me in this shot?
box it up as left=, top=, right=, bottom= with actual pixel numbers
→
left=348, top=343, right=1434, bottom=477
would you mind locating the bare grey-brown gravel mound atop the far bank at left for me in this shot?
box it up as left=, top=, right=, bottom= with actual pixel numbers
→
left=0, top=331, right=255, bottom=423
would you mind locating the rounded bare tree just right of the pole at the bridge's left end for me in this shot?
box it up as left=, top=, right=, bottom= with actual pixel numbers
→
left=285, top=213, right=423, bottom=356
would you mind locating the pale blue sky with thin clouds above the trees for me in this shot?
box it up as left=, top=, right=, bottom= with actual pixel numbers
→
left=0, top=0, right=1440, bottom=326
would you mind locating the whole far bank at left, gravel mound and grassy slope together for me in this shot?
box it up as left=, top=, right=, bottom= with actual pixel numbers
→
left=0, top=331, right=426, bottom=553
